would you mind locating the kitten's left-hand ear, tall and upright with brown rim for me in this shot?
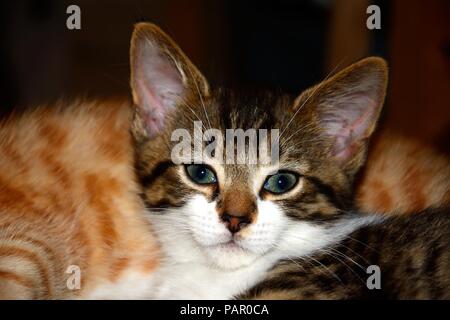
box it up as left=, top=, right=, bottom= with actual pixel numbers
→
left=130, top=23, right=209, bottom=138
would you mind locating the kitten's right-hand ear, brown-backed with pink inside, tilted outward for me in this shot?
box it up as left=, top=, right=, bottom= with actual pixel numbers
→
left=295, top=57, right=388, bottom=174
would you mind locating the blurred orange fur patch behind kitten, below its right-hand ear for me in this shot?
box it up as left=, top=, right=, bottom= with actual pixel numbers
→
left=356, top=132, right=450, bottom=213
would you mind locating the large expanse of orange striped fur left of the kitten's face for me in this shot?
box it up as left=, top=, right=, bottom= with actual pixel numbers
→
left=0, top=101, right=158, bottom=299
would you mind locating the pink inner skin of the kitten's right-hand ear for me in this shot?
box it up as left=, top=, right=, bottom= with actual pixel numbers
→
left=322, top=93, right=377, bottom=161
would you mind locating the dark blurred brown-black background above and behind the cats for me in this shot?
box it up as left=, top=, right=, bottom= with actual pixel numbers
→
left=0, top=0, right=450, bottom=153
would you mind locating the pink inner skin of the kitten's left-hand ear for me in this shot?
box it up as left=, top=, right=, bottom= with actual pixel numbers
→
left=135, top=42, right=185, bottom=137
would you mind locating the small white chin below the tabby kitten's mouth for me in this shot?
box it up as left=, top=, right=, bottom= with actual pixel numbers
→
left=205, top=244, right=258, bottom=270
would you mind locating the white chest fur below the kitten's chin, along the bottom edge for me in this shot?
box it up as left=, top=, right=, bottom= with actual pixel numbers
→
left=85, top=262, right=267, bottom=300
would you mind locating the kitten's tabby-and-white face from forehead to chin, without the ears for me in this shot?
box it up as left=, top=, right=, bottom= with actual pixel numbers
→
left=134, top=92, right=370, bottom=269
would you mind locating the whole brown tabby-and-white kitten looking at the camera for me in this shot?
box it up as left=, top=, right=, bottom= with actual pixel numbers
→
left=131, top=24, right=450, bottom=299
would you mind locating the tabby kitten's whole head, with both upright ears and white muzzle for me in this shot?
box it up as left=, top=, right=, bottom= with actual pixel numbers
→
left=131, top=24, right=387, bottom=269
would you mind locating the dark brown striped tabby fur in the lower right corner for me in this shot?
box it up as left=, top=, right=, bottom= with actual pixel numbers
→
left=243, top=209, right=450, bottom=300
